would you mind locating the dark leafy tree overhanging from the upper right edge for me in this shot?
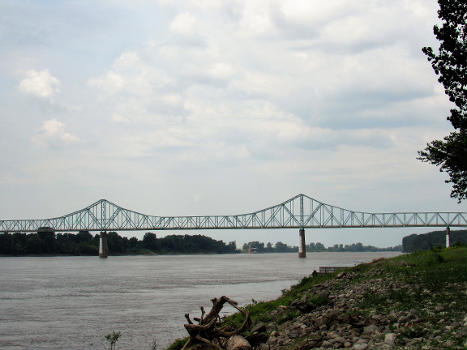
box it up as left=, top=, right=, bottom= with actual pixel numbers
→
left=418, top=0, right=467, bottom=202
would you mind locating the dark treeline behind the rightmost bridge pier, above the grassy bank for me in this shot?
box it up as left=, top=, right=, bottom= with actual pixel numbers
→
left=402, top=230, right=467, bottom=253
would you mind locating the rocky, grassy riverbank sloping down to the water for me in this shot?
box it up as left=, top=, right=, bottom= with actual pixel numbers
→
left=169, top=247, right=467, bottom=350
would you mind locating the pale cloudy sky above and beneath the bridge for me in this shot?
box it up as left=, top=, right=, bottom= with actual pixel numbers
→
left=0, top=0, right=465, bottom=247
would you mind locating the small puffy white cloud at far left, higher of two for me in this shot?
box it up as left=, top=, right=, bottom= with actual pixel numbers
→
left=19, top=69, right=60, bottom=99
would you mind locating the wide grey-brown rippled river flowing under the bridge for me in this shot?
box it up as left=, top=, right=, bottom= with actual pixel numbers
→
left=0, top=252, right=400, bottom=350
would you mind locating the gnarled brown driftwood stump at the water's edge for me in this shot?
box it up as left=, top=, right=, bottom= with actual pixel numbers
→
left=182, top=296, right=250, bottom=350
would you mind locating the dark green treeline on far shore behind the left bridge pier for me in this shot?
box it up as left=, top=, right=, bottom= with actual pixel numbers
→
left=0, top=230, right=239, bottom=256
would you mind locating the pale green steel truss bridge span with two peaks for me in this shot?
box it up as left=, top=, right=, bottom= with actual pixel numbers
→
left=0, top=194, right=467, bottom=232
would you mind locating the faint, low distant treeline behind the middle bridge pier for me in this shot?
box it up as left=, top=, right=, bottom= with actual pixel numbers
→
left=242, top=241, right=402, bottom=253
